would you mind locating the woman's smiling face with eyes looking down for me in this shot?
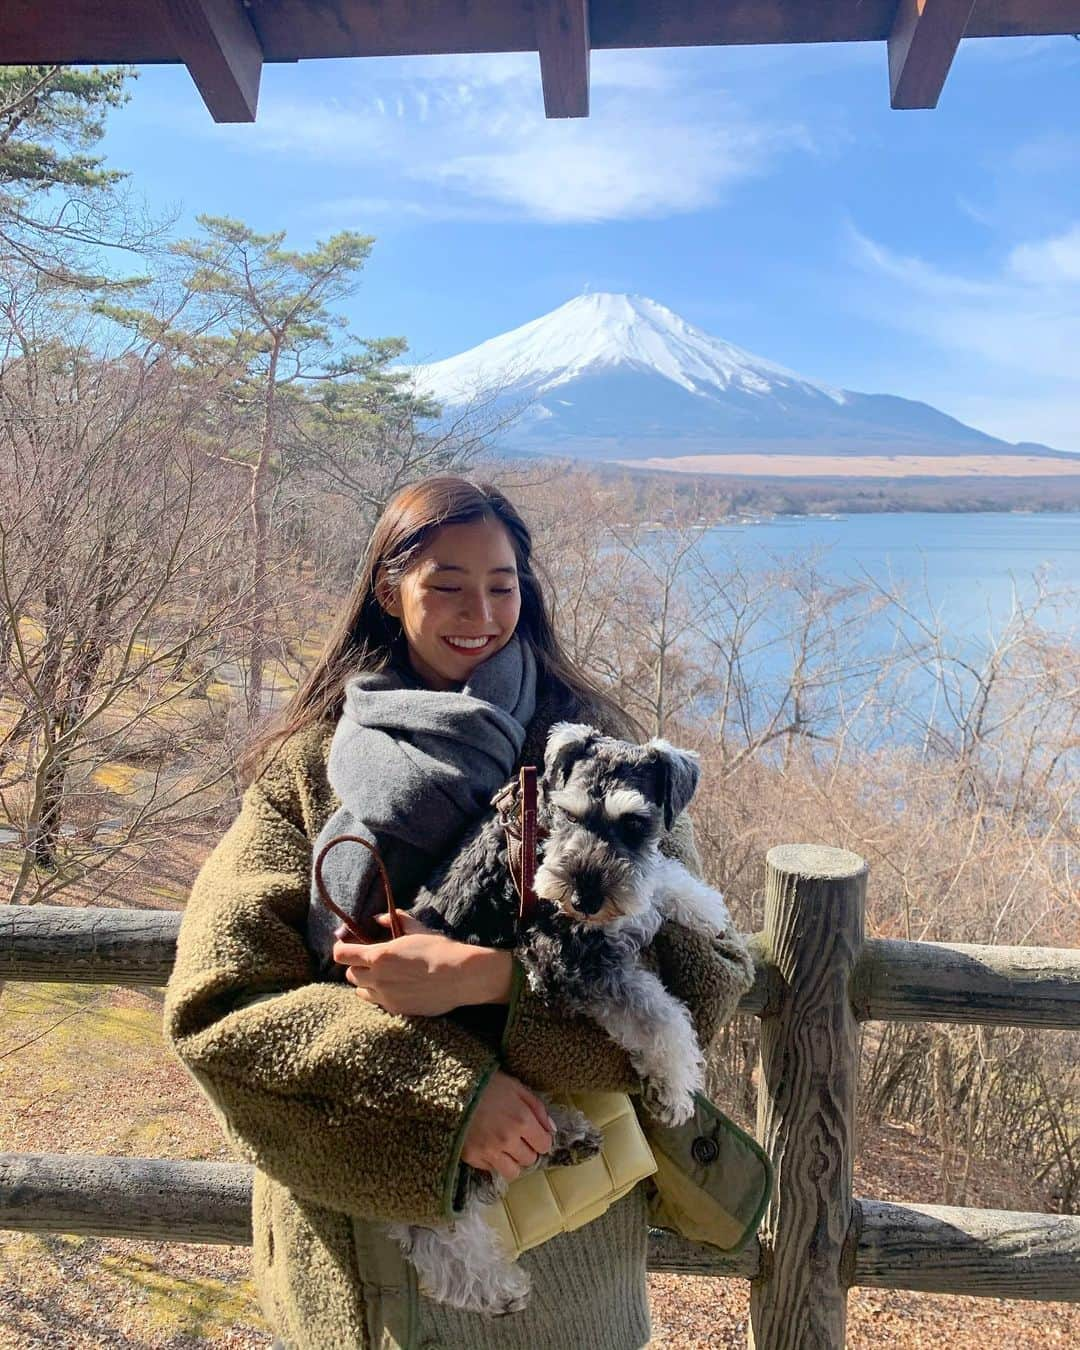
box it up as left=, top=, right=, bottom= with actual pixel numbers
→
left=379, top=520, right=521, bottom=689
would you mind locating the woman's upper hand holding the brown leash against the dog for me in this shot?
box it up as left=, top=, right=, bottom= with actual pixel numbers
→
left=332, top=910, right=513, bottom=1017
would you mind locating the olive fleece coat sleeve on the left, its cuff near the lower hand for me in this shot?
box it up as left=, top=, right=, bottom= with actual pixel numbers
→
left=163, top=745, right=498, bottom=1223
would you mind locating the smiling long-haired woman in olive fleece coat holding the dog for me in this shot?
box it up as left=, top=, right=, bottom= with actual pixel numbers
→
left=165, top=477, right=748, bottom=1350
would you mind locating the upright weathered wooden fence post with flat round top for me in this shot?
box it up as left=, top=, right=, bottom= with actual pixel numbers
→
left=749, top=844, right=867, bottom=1350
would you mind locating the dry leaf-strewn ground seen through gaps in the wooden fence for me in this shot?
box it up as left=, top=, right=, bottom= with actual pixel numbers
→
left=0, top=984, right=1080, bottom=1350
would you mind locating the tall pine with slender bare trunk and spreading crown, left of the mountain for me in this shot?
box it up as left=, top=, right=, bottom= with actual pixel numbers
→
left=96, top=215, right=433, bottom=724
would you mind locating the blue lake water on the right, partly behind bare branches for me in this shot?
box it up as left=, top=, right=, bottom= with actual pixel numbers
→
left=669, top=512, right=1080, bottom=744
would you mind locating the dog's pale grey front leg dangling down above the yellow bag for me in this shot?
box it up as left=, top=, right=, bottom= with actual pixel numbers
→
left=585, top=967, right=705, bottom=1125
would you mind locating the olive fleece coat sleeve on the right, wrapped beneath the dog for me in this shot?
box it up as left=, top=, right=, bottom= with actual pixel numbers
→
left=502, top=815, right=753, bottom=1092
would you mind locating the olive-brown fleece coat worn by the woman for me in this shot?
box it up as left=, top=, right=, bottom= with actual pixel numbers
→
left=163, top=685, right=744, bottom=1350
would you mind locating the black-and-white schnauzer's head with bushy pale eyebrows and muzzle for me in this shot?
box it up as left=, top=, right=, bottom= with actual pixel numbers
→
left=536, top=722, right=701, bottom=923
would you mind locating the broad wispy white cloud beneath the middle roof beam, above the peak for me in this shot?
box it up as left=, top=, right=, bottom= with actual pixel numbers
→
left=198, top=51, right=813, bottom=224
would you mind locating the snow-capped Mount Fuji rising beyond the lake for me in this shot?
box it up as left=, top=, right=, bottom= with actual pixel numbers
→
left=412, top=293, right=1076, bottom=459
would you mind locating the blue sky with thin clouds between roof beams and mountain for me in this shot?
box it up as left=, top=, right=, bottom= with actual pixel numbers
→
left=104, top=38, right=1080, bottom=451
